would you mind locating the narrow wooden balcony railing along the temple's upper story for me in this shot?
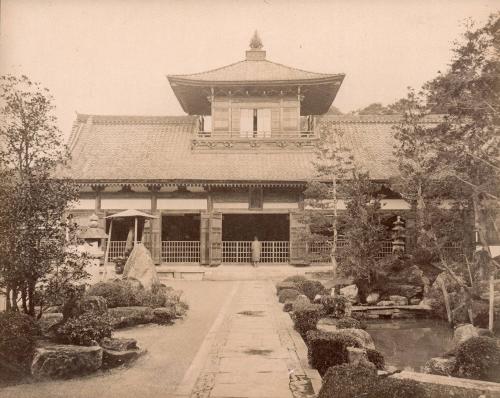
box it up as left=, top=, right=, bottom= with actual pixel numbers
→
left=197, top=130, right=315, bottom=140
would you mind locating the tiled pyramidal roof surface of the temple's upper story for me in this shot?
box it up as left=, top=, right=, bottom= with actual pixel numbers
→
left=169, top=59, right=343, bottom=82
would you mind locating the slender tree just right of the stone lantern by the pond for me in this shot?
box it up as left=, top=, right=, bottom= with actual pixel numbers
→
left=392, top=89, right=467, bottom=262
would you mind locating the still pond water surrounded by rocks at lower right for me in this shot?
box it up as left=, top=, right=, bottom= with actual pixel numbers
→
left=366, top=319, right=453, bottom=372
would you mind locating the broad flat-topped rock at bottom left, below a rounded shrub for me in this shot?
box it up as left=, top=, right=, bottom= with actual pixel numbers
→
left=31, top=344, right=103, bottom=379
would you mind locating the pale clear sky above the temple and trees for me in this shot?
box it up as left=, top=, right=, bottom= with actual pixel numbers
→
left=0, top=0, right=500, bottom=136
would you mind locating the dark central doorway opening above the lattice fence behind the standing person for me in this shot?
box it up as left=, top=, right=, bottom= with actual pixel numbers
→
left=222, top=214, right=290, bottom=241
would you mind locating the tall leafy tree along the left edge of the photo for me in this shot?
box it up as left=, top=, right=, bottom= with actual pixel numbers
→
left=0, top=76, right=86, bottom=316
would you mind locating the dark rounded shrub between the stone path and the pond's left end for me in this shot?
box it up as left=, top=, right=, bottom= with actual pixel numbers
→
left=306, top=330, right=362, bottom=376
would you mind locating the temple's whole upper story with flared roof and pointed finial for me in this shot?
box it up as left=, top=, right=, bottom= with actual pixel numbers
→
left=168, top=33, right=345, bottom=148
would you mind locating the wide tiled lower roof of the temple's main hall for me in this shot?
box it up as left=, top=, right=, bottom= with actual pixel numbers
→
left=65, top=115, right=442, bottom=182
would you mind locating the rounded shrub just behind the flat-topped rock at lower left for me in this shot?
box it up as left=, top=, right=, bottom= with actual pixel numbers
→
left=57, top=312, right=113, bottom=346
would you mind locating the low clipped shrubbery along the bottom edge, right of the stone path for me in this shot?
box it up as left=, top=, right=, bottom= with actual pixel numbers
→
left=318, top=364, right=427, bottom=398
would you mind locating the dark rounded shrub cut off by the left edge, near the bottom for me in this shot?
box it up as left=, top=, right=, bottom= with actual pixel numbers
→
left=0, top=311, right=39, bottom=374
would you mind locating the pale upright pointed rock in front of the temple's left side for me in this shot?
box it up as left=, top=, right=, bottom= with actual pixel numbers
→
left=123, top=244, right=160, bottom=289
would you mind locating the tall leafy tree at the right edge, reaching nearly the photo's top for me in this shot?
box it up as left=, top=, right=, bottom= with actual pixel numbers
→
left=424, top=12, right=500, bottom=272
